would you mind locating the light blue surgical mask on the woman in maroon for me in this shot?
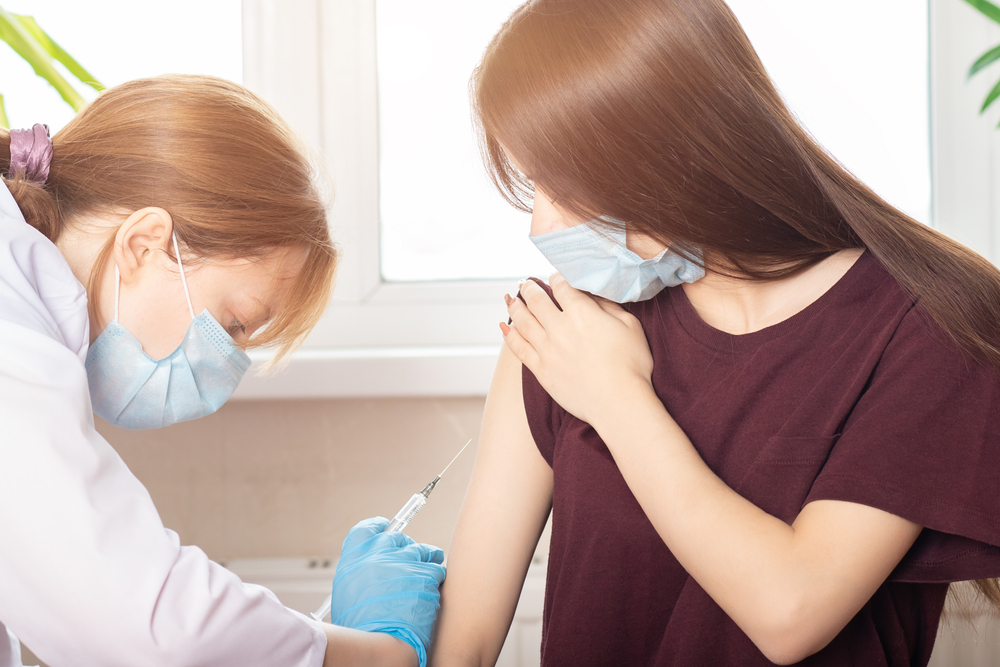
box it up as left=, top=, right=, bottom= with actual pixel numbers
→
left=531, top=222, right=705, bottom=303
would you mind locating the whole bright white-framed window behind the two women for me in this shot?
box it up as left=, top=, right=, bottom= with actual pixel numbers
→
left=0, top=0, right=944, bottom=397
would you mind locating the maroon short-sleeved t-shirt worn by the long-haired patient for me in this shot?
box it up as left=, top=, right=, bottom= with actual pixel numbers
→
left=524, top=253, right=1000, bottom=667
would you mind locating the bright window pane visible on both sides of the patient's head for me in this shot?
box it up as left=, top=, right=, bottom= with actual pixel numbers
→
left=376, top=0, right=930, bottom=281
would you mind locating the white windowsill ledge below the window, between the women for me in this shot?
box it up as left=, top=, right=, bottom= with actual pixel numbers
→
left=233, top=345, right=500, bottom=400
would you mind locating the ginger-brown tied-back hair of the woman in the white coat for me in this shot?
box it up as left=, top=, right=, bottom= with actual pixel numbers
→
left=0, top=75, right=337, bottom=358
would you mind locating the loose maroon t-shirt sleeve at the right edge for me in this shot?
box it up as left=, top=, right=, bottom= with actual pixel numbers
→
left=806, top=308, right=1000, bottom=583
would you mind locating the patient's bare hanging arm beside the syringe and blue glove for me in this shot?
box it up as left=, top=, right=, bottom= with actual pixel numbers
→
left=432, top=345, right=552, bottom=665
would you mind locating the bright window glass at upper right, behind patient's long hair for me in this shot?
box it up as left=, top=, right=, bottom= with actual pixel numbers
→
left=728, top=0, right=931, bottom=223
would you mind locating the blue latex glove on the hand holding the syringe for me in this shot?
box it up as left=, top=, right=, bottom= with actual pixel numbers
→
left=330, top=517, right=445, bottom=667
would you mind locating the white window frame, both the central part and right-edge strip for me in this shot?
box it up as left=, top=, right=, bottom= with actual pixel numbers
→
left=236, top=0, right=984, bottom=398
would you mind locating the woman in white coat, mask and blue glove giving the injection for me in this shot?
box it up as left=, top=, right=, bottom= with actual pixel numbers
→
left=0, top=76, right=444, bottom=667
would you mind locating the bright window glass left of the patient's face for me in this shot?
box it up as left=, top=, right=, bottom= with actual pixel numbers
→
left=375, top=0, right=553, bottom=281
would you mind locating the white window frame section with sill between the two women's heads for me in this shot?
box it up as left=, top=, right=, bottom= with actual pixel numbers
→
left=235, top=0, right=508, bottom=398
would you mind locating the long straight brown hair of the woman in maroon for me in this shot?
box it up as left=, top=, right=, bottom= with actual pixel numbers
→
left=470, top=0, right=1000, bottom=607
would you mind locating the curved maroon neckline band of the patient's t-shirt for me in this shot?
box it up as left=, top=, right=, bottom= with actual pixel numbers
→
left=669, top=249, right=875, bottom=352
